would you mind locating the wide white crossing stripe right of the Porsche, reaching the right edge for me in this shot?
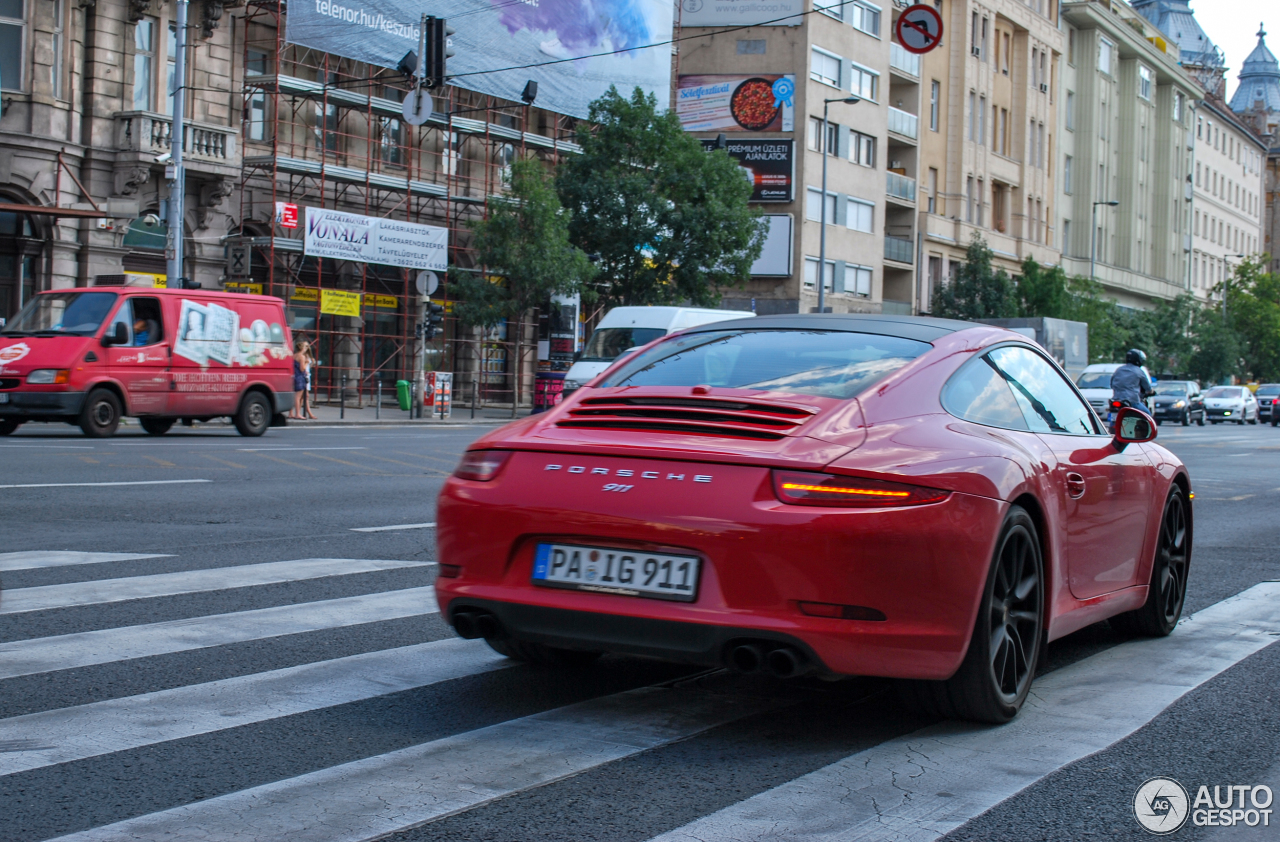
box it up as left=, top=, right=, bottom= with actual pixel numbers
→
left=654, top=582, right=1280, bottom=842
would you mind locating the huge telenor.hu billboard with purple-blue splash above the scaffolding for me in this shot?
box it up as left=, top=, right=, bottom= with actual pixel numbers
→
left=284, top=0, right=673, bottom=118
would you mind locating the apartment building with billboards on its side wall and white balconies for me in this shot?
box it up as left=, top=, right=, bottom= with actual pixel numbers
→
left=676, top=0, right=920, bottom=314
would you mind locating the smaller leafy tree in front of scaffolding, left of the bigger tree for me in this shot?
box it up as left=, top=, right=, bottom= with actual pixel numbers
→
left=453, top=159, right=595, bottom=417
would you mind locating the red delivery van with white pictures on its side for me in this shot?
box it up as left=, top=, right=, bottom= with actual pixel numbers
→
left=0, top=287, right=293, bottom=436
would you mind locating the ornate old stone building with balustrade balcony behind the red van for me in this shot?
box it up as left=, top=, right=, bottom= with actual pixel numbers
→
left=0, top=0, right=241, bottom=319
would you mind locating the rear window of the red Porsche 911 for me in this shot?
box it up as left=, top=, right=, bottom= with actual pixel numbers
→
left=600, top=329, right=932, bottom=399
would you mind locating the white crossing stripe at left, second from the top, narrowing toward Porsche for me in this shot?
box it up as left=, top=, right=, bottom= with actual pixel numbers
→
left=0, top=558, right=435, bottom=614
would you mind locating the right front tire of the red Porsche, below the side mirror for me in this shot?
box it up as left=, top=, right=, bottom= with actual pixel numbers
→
left=1111, top=485, right=1192, bottom=637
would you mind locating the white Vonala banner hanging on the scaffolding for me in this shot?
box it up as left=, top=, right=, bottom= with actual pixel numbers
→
left=302, top=207, right=449, bottom=271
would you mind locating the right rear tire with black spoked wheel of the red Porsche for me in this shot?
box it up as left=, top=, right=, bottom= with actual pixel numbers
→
left=899, top=505, right=1044, bottom=724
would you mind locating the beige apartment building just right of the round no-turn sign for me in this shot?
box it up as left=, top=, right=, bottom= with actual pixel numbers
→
left=918, top=0, right=1070, bottom=311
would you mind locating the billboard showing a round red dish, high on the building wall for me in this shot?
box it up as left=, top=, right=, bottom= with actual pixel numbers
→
left=676, top=73, right=796, bottom=132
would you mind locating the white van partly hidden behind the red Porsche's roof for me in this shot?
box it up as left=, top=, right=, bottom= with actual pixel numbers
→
left=564, top=307, right=755, bottom=394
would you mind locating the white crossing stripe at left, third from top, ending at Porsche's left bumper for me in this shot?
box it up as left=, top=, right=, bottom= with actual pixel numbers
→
left=0, top=587, right=439, bottom=679
